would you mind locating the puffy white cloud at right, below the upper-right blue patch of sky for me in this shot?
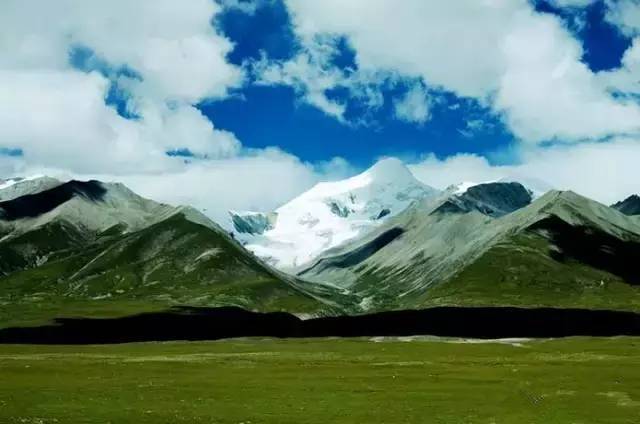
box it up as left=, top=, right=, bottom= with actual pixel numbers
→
left=494, top=9, right=640, bottom=141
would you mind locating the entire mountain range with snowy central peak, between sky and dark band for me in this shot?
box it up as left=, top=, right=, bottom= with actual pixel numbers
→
left=0, top=159, right=640, bottom=327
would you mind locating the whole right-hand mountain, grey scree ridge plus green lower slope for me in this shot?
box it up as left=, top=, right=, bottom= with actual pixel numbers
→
left=299, top=183, right=640, bottom=310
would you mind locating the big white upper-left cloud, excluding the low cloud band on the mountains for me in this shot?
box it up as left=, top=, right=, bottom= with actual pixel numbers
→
left=0, top=0, right=242, bottom=174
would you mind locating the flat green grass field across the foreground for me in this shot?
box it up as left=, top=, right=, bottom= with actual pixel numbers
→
left=0, top=338, right=640, bottom=424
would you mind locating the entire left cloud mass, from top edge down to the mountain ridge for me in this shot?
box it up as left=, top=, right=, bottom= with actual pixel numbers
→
left=0, top=0, right=349, bottom=222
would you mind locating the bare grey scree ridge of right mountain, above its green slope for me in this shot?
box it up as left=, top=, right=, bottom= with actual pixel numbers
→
left=298, top=191, right=640, bottom=310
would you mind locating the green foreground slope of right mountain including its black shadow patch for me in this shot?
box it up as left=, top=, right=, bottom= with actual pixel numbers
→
left=416, top=219, right=640, bottom=310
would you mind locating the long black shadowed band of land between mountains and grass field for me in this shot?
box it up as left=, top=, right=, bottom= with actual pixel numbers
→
left=0, top=307, right=640, bottom=344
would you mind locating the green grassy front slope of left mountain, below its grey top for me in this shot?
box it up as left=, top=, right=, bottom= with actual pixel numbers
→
left=0, top=215, right=323, bottom=326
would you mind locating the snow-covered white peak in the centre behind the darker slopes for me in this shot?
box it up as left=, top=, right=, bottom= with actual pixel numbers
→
left=230, top=158, right=439, bottom=269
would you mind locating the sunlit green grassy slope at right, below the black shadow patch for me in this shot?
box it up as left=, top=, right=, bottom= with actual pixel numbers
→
left=418, top=233, right=640, bottom=311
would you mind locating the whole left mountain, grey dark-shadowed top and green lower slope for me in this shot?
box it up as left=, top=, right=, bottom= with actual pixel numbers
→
left=0, top=181, right=340, bottom=323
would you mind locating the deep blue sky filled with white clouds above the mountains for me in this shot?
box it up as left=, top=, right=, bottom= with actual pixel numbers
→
left=0, top=0, right=640, bottom=223
